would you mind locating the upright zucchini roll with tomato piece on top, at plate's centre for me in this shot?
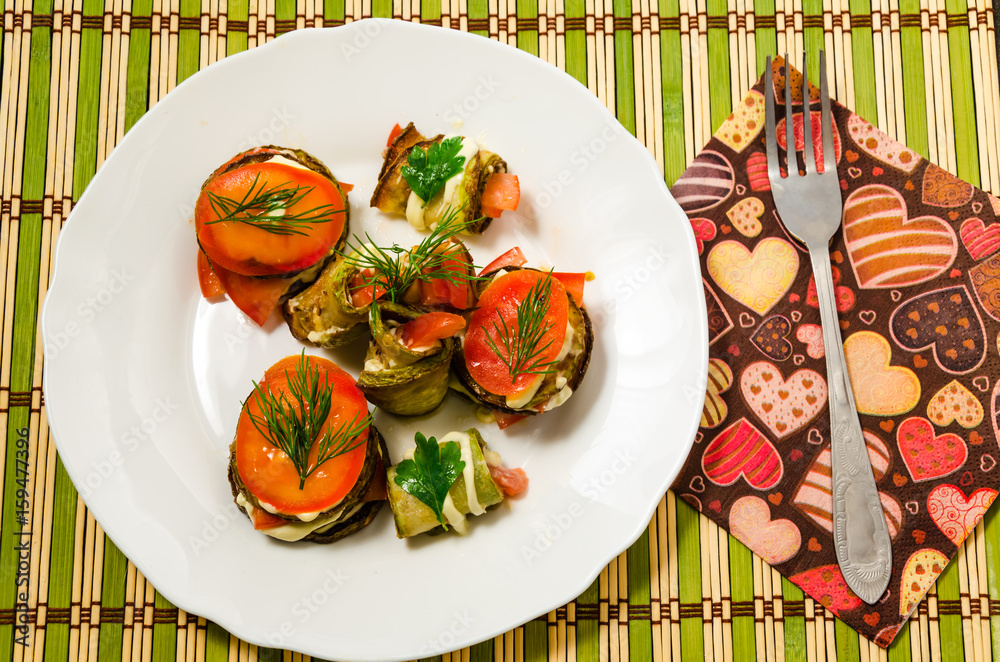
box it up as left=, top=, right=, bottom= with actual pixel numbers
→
left=358, top=301, right=465, bottom=416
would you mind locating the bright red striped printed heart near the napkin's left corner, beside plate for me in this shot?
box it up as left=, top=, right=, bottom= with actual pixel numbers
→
left=701, top=418, right=784, bottom=490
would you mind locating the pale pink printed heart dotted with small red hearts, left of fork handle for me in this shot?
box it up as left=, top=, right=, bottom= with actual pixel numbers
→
left=740, top=361, right=826, bottom=439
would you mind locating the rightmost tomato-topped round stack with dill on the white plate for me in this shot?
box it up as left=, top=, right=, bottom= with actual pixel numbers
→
left=452, top=256, right=594, bottom=427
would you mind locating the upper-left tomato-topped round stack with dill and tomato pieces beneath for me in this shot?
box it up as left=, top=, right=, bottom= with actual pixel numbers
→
left=194, top=145, right=350, bottom=326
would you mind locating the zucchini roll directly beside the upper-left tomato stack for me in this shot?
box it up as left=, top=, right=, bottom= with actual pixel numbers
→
left=281, top=255, right=371, bottom=348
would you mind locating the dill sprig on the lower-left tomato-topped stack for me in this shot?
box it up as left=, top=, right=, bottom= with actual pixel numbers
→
left=243, top=351, right=372, bottom=490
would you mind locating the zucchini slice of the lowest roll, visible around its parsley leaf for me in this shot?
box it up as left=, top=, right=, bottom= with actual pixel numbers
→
left=386, top=428, right=504, bottom=538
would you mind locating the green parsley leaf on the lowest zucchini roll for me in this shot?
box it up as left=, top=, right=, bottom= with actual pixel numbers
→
left=393, top=432, right=465, bottom=531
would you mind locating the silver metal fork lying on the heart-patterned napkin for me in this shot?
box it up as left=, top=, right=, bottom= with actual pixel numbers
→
left=765, top=51, right=892, bottom=604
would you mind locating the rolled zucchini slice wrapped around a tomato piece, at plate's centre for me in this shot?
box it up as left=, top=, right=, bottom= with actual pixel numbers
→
left=358, top=301, right=455, bottom=416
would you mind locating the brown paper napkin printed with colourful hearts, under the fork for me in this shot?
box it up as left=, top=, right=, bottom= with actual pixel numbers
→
left=672, top=60, right=1000, bottom=647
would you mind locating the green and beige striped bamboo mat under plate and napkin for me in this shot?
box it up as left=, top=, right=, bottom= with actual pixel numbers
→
left=0, top=0, right=1000, bottom=662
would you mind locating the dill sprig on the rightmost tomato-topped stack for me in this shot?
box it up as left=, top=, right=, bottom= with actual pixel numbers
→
left=485, top=271, right=558, bottom=384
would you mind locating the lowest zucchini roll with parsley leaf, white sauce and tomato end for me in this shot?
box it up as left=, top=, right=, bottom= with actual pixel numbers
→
left=386, top=428, right=528, bottom=538
